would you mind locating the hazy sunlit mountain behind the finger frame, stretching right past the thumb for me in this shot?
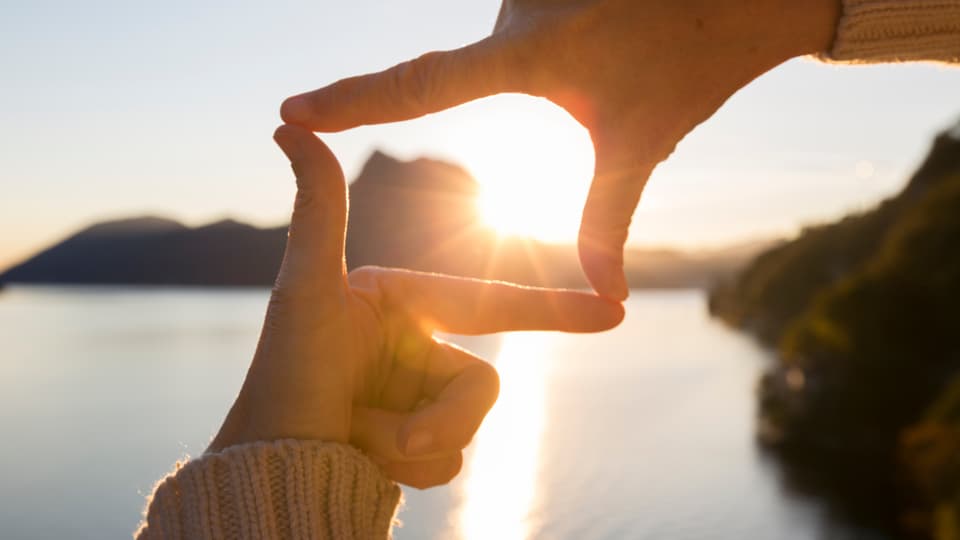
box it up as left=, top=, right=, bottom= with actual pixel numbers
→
left=346, top=152, right=760, bottom=288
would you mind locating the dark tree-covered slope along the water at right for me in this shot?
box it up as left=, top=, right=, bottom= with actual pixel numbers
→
left=710, top=120, right=960, bottom=538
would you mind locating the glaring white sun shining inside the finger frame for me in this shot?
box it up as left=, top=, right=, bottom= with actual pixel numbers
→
left=450, top=95, right=594, bottom=243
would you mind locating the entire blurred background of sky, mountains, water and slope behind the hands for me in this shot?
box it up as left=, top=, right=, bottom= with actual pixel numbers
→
left=0, top=0, right=960, bottom=539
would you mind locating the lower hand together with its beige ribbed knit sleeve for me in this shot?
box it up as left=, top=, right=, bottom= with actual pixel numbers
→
left=138, top=126, right=623, bottom=539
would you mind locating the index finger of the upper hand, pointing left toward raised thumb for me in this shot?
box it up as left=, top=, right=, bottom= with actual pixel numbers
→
left=280, top=36, right=521, bottom=132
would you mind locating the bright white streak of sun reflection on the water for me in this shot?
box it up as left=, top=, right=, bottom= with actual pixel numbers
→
left=456, top=333, right=550, bottom=540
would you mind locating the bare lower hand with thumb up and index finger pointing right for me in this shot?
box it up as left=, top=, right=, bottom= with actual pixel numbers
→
left=210, top=126, right=623, bottom=488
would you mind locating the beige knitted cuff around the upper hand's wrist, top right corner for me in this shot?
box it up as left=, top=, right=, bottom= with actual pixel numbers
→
left=824, top=0, right=960, bottom=63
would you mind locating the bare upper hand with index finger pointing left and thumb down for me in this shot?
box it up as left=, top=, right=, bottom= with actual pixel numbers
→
left=281, top=0, right=839, bottom=300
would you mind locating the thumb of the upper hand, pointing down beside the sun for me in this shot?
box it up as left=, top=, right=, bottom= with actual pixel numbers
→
left=578, top=129, right=656, bottom=301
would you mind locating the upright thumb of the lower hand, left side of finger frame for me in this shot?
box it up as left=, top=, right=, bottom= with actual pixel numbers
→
left=273, top=125, right=347, bottom=292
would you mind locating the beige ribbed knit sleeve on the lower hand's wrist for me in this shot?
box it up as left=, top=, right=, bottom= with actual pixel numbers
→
left=135, top=440, right=400, bottom=540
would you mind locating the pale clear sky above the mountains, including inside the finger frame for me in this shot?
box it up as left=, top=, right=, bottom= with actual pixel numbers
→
left=0, top=0, right=960, bottom=267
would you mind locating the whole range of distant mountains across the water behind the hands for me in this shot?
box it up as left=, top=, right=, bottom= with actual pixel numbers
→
left=0, top=152, right=761, bottom=288
